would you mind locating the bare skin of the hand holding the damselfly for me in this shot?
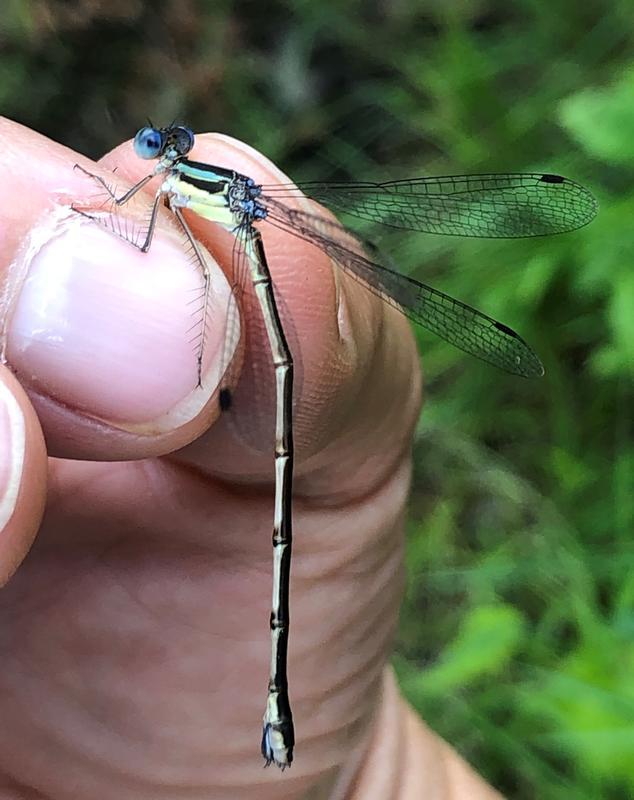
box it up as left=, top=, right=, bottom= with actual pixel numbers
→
left=0, top=120, right=498, bottom=800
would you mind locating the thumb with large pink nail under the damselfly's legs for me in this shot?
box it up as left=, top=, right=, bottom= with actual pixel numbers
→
left=0, top=115, right=237, bottom=459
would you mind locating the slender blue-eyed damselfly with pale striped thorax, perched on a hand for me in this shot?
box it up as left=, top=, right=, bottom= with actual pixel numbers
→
left=73, top=124, right=596, bottom=769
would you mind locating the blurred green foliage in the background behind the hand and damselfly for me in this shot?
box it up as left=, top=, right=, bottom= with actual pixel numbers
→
left=0, top=0, right=634, bottom=800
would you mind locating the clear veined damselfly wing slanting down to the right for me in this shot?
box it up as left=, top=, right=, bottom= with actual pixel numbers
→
left=266, top=199, right=544, bottom=378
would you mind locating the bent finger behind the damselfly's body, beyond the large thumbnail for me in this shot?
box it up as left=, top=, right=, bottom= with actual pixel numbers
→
left=102, top=134, right=420, bottom=500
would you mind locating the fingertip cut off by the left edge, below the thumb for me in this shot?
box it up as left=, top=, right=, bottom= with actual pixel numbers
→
left=0, top=367, right=46, bottom=586
